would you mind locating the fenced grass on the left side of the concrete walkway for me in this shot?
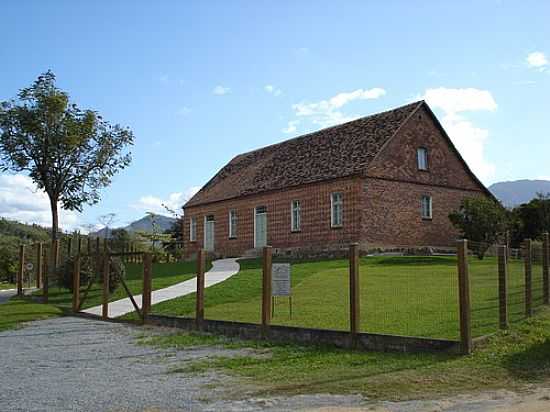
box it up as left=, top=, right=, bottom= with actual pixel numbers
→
left=38, top=262, right=210, bottom=309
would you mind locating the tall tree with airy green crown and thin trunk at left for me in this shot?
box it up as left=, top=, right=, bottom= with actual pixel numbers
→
left=0, top=71, right=134, bottom=239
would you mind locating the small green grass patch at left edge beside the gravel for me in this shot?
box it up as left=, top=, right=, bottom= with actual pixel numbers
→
left=0, top=298, right=62, bottom=331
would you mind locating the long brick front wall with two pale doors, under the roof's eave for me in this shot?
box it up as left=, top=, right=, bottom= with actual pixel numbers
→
left=183, top=178, right=364, bottom=256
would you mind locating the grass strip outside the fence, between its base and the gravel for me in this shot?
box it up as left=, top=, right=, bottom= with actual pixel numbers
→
left=142, top=308, right=550, bottom=400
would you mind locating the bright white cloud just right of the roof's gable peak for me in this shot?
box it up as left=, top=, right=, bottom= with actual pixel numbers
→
left=423, top=87, right=497, bottom=180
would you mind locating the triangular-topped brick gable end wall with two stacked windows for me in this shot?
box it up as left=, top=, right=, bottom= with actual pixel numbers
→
left=362, top=104, right=490, bottom=246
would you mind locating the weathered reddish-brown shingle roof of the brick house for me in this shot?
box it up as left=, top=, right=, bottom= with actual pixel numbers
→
left=185, top=101, right=423, bottom=207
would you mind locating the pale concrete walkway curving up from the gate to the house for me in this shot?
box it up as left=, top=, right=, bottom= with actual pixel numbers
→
left=83, top=258, right=239, bottom=318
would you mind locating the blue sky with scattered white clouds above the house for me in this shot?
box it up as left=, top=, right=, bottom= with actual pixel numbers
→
left=0, top=0, right=550, bottom=231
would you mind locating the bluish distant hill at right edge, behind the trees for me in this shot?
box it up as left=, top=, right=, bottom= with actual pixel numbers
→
left=489, top=180, right=550, bottom=207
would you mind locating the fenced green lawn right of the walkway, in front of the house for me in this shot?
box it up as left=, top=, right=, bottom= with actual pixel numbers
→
left=144, top=256, right=542, bottom=339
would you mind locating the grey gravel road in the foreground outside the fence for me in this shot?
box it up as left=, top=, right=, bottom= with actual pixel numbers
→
left=0, top=317, right=550, bottom=412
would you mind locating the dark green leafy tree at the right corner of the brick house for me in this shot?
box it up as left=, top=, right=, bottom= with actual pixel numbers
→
left=449, top=197, right=506, bottom=259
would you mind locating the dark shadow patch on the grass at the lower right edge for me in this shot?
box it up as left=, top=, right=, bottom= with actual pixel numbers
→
left=504, top=338, right=550, bottom=380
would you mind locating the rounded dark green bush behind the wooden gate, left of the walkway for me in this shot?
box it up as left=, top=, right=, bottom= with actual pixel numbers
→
left=57, top=256, right=126, bottom=293
